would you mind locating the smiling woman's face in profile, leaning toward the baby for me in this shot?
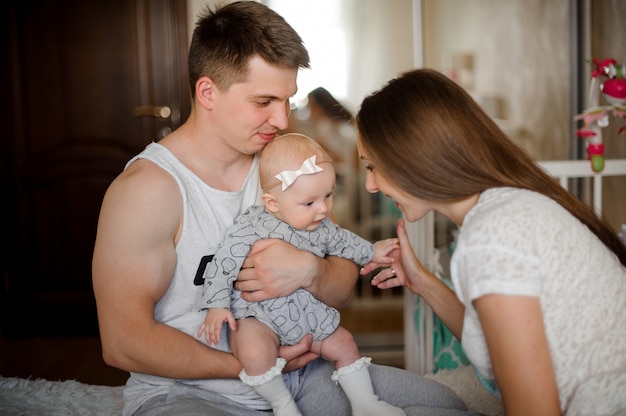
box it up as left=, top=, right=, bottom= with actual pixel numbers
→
left=357, top=137, right=434, bottom=222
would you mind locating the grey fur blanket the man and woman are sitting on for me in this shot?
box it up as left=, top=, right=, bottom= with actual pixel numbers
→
left=0, top=367, right=504, bottom=416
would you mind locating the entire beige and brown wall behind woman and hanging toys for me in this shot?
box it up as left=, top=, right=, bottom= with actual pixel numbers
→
left=422, top=0, right=626, bottom=230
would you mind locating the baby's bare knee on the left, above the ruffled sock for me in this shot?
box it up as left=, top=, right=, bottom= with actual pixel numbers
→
left=230, top=318, right=279, bottom=376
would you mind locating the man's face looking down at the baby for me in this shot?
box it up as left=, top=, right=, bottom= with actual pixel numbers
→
left=211, top=57, right=298, bottom=154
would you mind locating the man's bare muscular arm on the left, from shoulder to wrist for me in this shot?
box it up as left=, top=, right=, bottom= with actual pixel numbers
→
left=93, top=160, right=242, bottom=378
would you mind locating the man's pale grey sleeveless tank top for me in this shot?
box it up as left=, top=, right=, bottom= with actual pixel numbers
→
left=124, top=143, right=268, bottom=415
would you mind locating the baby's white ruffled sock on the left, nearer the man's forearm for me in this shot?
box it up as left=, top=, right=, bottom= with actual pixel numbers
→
left=239, top=358, right=302, bottom=416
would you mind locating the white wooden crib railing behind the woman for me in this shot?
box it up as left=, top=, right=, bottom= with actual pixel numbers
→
left=404, top=159, right=626, bottom=374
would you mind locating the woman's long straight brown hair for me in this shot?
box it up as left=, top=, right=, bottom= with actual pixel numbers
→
left=356, top=69, right=626, bottom=265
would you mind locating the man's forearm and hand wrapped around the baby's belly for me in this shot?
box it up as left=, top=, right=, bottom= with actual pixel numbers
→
left=235, top=239, right=358, bottom=309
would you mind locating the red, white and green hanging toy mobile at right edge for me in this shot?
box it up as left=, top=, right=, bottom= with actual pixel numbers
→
left=574, top=58, right=626, bottom=172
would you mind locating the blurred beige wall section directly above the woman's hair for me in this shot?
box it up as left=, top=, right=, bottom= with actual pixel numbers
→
left=423, top=0, right=570, bottom=159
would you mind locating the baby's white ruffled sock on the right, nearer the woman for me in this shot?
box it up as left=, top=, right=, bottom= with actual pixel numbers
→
left=331, top=357, right=404, bottom=416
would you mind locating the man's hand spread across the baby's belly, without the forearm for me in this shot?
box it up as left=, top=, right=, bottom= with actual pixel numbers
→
left=235, top=239, right=323, bottom=302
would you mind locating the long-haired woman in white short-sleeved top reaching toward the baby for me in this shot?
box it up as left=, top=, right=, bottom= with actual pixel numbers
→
left=356, top=69, right=626, bottom=415
